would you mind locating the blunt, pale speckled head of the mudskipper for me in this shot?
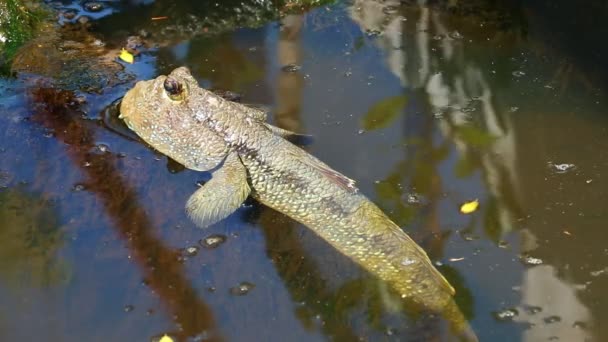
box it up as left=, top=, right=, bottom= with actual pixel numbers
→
left=119, top=67, right=228, bottom=171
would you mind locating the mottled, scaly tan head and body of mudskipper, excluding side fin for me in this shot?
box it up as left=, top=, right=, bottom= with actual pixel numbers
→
left=121, top=68, right=474, bottom=340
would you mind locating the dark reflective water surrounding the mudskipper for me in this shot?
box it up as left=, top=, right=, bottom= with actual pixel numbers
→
left=0, top=1, right=608, bottom=341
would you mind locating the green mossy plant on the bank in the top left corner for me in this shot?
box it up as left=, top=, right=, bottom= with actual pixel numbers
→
left=0, top=0, right=44, bottom=74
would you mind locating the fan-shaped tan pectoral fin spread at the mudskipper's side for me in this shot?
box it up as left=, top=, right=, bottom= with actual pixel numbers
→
left=186, top=152, right=251, bottom=228
